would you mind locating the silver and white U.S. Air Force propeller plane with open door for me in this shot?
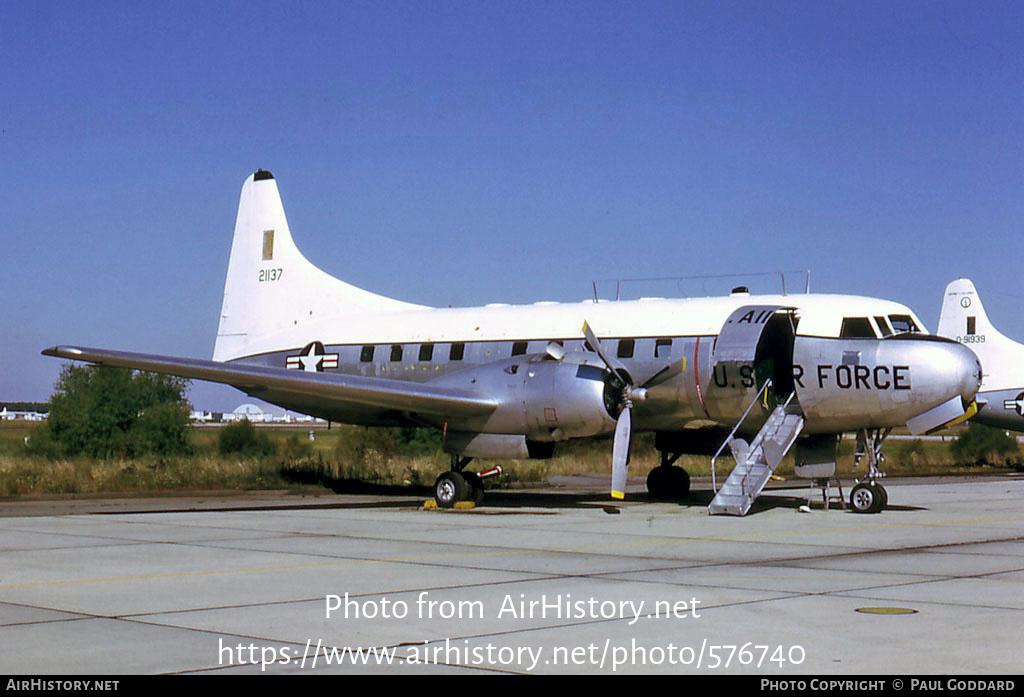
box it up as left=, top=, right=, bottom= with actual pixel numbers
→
left=43, top=170, right=981, bottom=515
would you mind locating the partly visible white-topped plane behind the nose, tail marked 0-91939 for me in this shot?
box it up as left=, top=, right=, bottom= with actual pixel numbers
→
left=937, top=278, right=1024, bottom=431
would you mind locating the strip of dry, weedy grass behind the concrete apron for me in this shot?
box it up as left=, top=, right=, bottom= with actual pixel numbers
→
left=0, top=415, right=1007, bottom=497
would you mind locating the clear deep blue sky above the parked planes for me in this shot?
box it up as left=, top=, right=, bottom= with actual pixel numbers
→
left=0, top=0, right=1024, bottom=409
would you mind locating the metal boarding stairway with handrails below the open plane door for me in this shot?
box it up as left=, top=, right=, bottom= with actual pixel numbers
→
left=708, top=381, right=805, bottom=516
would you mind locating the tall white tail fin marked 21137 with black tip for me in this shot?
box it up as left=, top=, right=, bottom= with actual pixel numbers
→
left=213, top=170, right=420, bottom=360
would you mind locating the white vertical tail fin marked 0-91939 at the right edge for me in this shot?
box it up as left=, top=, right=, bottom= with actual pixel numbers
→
left=937, top=278, right=1024, bottom=392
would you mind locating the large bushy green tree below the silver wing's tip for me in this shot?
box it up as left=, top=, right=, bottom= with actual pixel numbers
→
left=46, top=365, right=191, bottom=458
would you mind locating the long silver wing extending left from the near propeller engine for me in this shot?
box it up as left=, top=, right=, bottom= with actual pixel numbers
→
left=43, top=346, right=498, bottom=418
